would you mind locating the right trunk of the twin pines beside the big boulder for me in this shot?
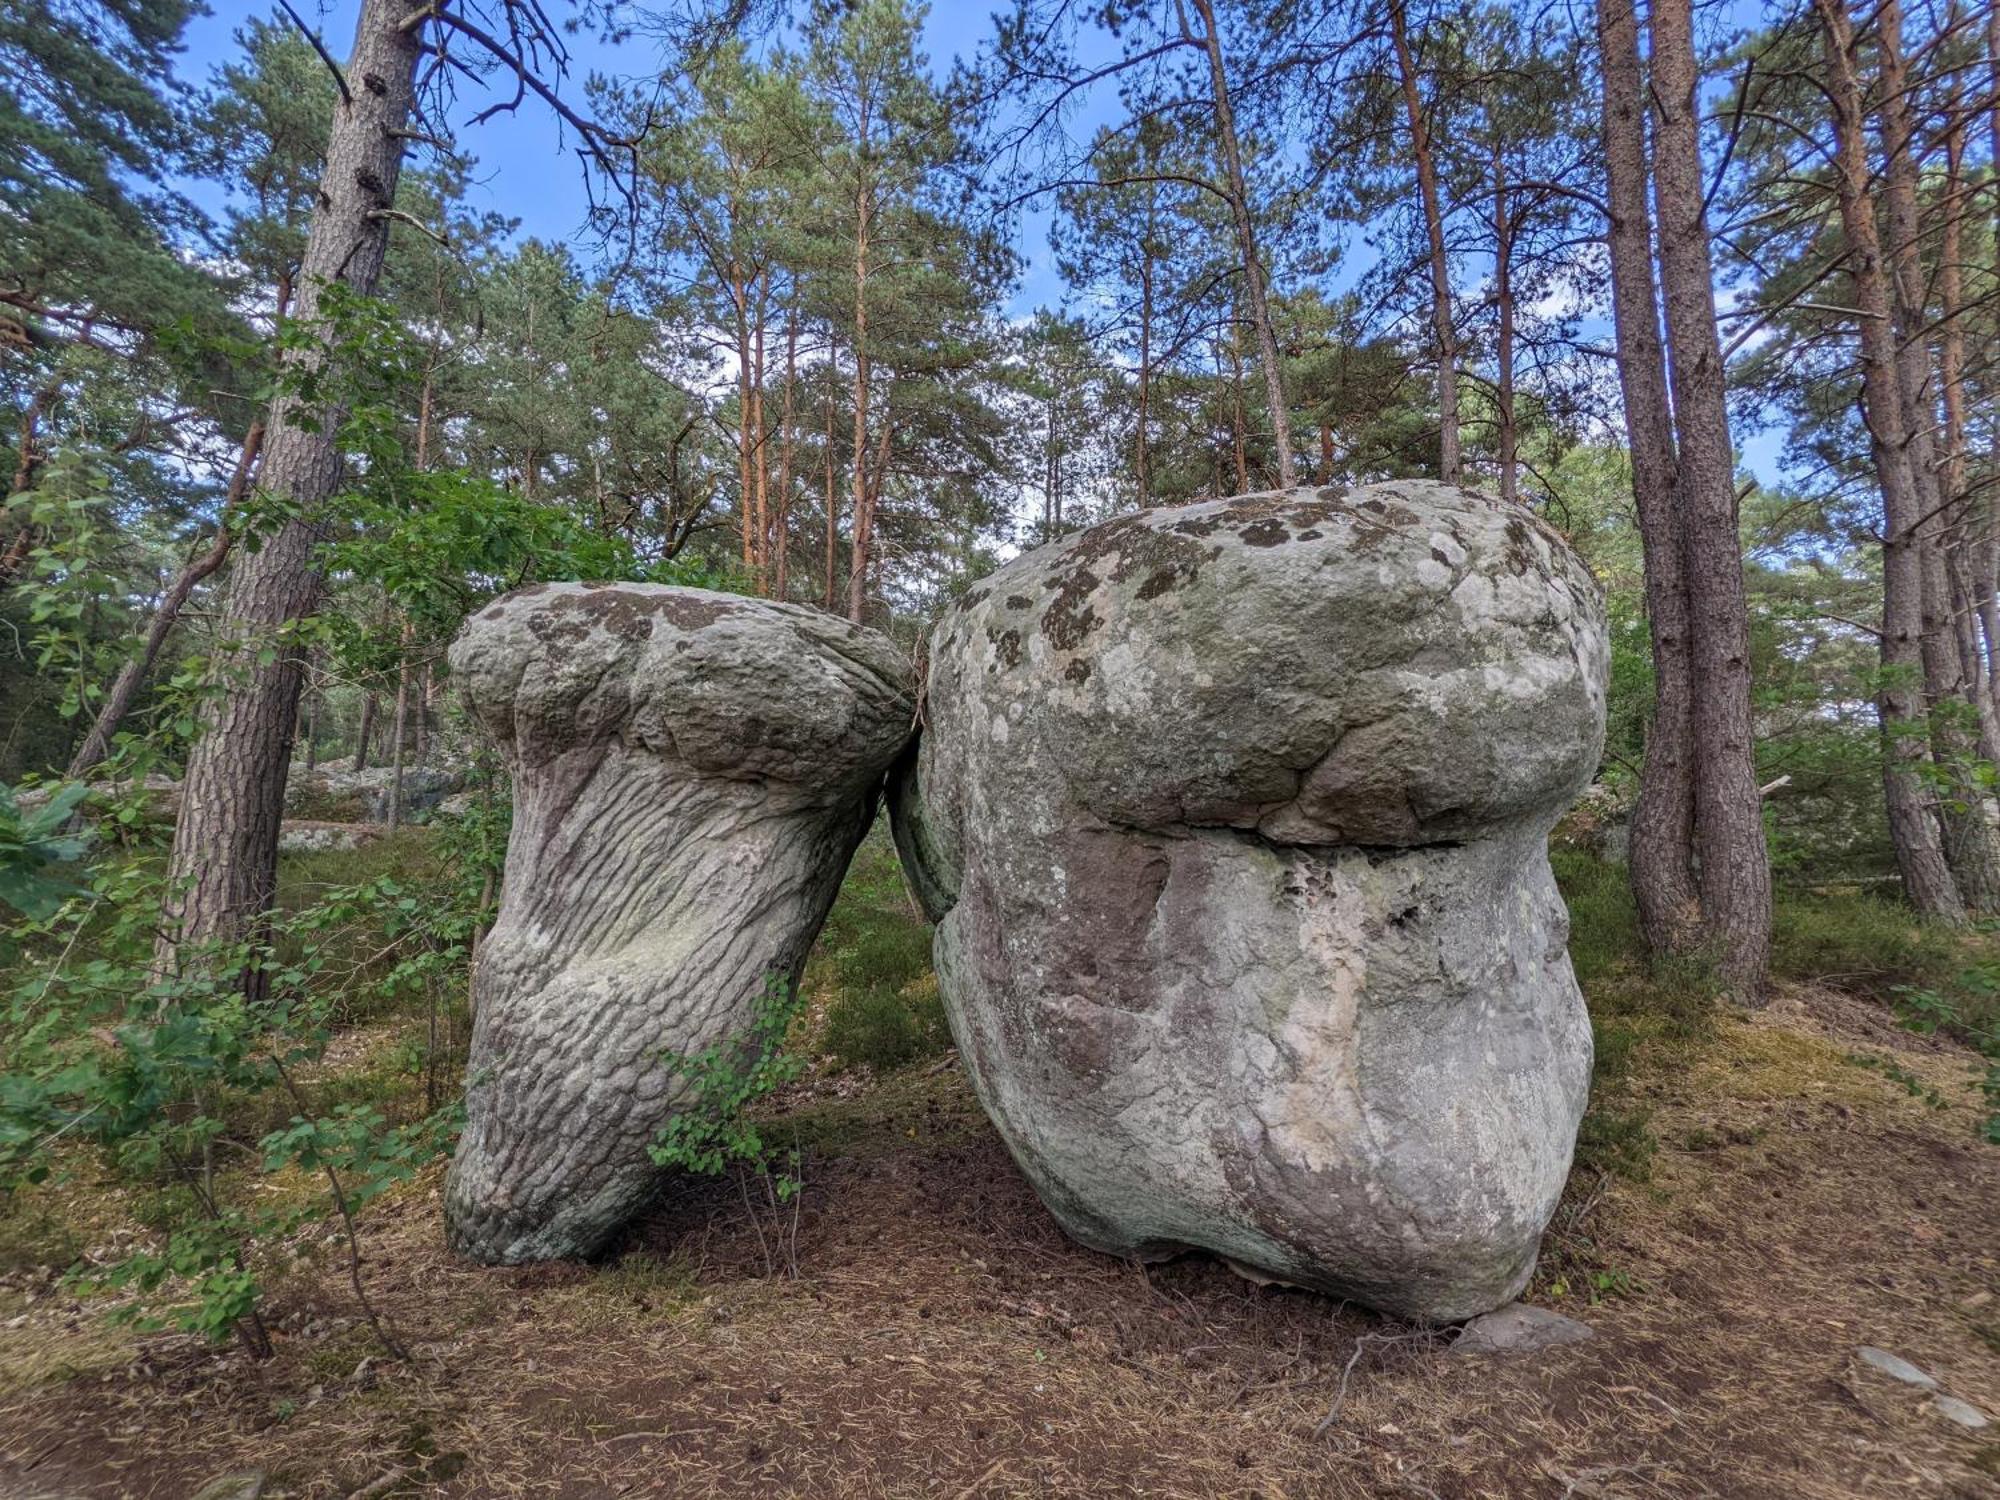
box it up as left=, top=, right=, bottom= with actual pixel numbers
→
left=1652, top=0, right=1770, bottom=998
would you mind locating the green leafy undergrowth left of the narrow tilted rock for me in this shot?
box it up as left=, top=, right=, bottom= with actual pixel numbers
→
left=0, top=794, right=506, bottom=1356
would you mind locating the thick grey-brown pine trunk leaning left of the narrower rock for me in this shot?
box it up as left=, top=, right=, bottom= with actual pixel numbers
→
left=154, top=0, right=424, bottom=994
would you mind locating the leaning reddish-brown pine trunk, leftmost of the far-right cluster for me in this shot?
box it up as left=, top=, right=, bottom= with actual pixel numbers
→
left=1812, top=0, right=1966, bottom=920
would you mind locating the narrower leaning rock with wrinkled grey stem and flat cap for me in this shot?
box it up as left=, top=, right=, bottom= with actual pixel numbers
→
left=446, top=584, right=916, bottom=1262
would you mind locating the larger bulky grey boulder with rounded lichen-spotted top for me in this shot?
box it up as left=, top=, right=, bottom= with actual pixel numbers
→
left=892, top=482, right=1608, bottom=1320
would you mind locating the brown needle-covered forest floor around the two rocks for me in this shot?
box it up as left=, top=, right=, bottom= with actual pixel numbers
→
left=0, top=846, right=2000, bottom=1500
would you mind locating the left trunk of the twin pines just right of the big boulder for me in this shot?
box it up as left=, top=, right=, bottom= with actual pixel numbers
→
left=1598, top=0, right=1700, bottom=954
